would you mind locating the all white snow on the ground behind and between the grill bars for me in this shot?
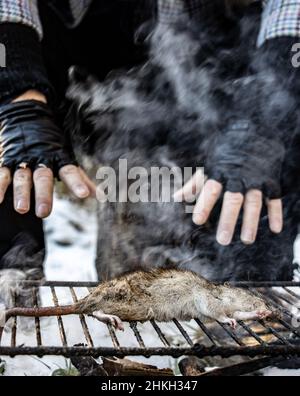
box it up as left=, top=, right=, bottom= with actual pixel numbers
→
left=3, top=198, right=300, bottom=376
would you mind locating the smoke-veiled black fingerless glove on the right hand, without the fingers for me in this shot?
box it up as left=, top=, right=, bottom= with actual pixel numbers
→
left=207, top=120, right=285, bottom=199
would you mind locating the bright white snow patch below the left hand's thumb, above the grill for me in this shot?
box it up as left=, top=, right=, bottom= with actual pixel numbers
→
left=45, top=195, right=97, bottom=281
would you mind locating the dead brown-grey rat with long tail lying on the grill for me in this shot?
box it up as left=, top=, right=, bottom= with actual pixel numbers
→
left=5, top=269, right=279, bottom=330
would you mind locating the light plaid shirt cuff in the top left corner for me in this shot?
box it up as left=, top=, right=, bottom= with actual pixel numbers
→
left=0, top=0, right=42, bottom=37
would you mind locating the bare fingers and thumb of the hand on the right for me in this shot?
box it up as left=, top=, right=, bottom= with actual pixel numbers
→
left=174, top=171, right=283, bottom=246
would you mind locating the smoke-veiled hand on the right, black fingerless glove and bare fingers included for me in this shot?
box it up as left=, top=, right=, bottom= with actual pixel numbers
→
left=175, top=114, right=285, bottom=246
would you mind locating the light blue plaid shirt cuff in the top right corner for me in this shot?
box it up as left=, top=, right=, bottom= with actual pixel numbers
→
left=257, top=0, right=300, bottom=46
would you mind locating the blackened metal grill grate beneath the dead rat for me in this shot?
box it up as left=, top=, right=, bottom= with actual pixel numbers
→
left=0, top=282, right=300, bottom=376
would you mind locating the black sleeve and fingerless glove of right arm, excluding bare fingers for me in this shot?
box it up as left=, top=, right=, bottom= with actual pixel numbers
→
left=206, top=38, right=300, bottom=199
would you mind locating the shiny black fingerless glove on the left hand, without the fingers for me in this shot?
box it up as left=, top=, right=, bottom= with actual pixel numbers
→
left=0, top=100, right=76, bottom=176
